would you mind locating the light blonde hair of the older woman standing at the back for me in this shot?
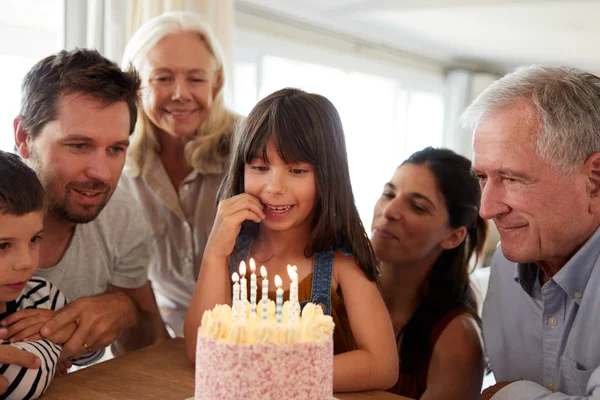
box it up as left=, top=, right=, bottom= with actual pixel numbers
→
left=121, top=11, right=239, bottom=176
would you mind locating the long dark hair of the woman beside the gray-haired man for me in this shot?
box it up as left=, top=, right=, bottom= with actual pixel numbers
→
left=398, top=147, right=487, bottom=374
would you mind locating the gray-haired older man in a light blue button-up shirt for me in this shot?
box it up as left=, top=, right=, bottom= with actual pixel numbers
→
left=463, top=67, right=600, bottom=400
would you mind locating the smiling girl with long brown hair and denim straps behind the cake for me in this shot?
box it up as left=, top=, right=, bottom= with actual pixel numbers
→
left=185, top=89, right=398, bottom=392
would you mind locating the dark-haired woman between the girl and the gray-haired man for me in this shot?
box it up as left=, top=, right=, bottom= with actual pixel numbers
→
left=371, top=147, right=487, bottom=400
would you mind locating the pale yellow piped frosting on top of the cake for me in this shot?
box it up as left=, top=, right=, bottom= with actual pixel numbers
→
left=200, top=300, right=334, bottom=344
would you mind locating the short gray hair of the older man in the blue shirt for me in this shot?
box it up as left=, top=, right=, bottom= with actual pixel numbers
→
left=460, top=66, right=600, bottom=174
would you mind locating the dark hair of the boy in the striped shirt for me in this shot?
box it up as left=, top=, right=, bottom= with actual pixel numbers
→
left=0, top=150, right=46, bottom=215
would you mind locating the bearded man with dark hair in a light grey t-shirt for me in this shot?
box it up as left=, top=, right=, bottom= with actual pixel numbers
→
left=0, top=49, right=168, bottom=362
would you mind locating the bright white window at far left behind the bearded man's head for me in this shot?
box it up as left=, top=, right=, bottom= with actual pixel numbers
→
left=0, top=0, right=64, bottom=151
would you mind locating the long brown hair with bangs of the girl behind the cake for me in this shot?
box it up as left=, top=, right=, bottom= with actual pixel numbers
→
left=218, top=88, right=378, bottom=281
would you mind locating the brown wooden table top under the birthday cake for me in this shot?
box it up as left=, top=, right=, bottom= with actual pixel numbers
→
left=40, top=338, right=408, bottom=400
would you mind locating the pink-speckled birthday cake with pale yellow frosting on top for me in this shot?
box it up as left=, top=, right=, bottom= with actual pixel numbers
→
left=195, top=264, right=334, bottom=400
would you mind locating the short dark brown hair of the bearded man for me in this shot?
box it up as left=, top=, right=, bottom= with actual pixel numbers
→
left=20, top=49, right=140, bottom=137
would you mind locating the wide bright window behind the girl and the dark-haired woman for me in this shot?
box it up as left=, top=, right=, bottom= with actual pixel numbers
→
left=234, top=27, right=444, bottom=232
